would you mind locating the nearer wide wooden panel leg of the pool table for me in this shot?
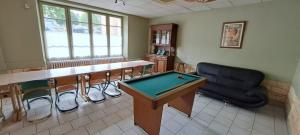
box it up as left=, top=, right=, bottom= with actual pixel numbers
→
left=133, top=99, right=163, bottom=135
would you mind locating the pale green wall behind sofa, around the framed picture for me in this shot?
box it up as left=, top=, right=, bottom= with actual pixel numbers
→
left=150, top=0, right=300, bottom=82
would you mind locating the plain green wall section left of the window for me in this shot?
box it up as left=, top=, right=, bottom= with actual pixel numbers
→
left=0, top=0, right=45, bottom=68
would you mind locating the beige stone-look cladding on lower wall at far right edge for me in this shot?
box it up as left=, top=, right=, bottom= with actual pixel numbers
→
left=286, top=87, right=300, bottom=135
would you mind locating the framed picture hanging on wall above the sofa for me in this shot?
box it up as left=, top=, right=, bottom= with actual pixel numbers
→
left=220, top=21, right=246, bottom=48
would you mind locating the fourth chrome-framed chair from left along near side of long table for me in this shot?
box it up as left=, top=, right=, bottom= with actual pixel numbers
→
left=104, top=69, right=123, bottom=97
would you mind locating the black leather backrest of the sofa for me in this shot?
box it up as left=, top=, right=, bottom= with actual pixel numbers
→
left=197, top=62, right=264, bottom=91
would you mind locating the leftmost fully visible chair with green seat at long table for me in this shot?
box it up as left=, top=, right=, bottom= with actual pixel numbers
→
left=19, top=80, right=53, bottom=122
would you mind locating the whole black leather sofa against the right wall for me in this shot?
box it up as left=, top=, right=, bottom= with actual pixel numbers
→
left=195, top=62, right=267, bottom=108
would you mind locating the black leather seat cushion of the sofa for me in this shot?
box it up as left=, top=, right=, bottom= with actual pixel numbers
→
left=200, top=82, right=261, bottom=103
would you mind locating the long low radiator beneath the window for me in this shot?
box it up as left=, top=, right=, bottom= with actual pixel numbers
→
left=47, top=57, right=126, bottom=69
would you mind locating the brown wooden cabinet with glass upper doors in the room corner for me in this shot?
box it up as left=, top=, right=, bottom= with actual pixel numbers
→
left=146, top=23, right=178, bottom=72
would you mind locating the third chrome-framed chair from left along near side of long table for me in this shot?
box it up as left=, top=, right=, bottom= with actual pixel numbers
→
left=86, top=71, right=109, bottom=103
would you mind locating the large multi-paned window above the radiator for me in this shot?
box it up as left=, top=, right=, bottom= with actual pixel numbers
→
left=41, top=3, right=123, bottom=60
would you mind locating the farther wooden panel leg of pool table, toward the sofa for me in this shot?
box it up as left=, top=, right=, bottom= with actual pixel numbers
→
left=168, top=91, right=196, bottom=117
